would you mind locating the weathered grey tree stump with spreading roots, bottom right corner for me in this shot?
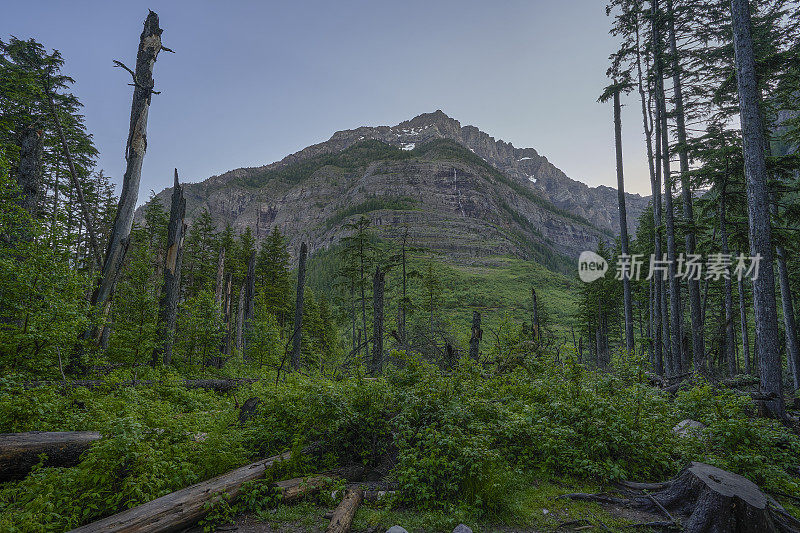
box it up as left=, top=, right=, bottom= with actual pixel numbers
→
left=635, top=462, right=800, bottom=533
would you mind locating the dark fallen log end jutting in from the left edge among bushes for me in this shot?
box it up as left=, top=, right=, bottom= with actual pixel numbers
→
left=0, top=431, right=100, bottom=482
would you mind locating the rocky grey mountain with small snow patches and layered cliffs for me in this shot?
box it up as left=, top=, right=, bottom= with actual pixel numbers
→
left=141, top=111, right=647, bottom=271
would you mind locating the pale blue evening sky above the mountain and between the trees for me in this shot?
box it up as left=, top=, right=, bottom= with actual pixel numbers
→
left=0, top=0, right=649, bottom=200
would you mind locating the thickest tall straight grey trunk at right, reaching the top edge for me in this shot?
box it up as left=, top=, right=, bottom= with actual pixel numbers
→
left=731, top=0, right=785, bottom=419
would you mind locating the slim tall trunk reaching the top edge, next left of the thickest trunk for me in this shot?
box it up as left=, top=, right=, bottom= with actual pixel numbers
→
left=667, top=0, right=705, bottom=373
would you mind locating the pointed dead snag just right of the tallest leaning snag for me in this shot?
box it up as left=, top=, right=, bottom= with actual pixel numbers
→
left=152, top=168, right=186, bottom=366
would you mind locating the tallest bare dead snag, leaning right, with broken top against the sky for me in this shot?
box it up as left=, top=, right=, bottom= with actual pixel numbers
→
left=92, top=11, right=168, bottom=312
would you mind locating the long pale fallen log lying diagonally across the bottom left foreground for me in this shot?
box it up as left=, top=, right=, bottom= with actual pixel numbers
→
left=72, top=452, right=291, bottom=533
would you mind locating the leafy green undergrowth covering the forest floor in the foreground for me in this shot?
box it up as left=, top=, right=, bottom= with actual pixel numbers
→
left=0, top=352, right=800, bottom=531
